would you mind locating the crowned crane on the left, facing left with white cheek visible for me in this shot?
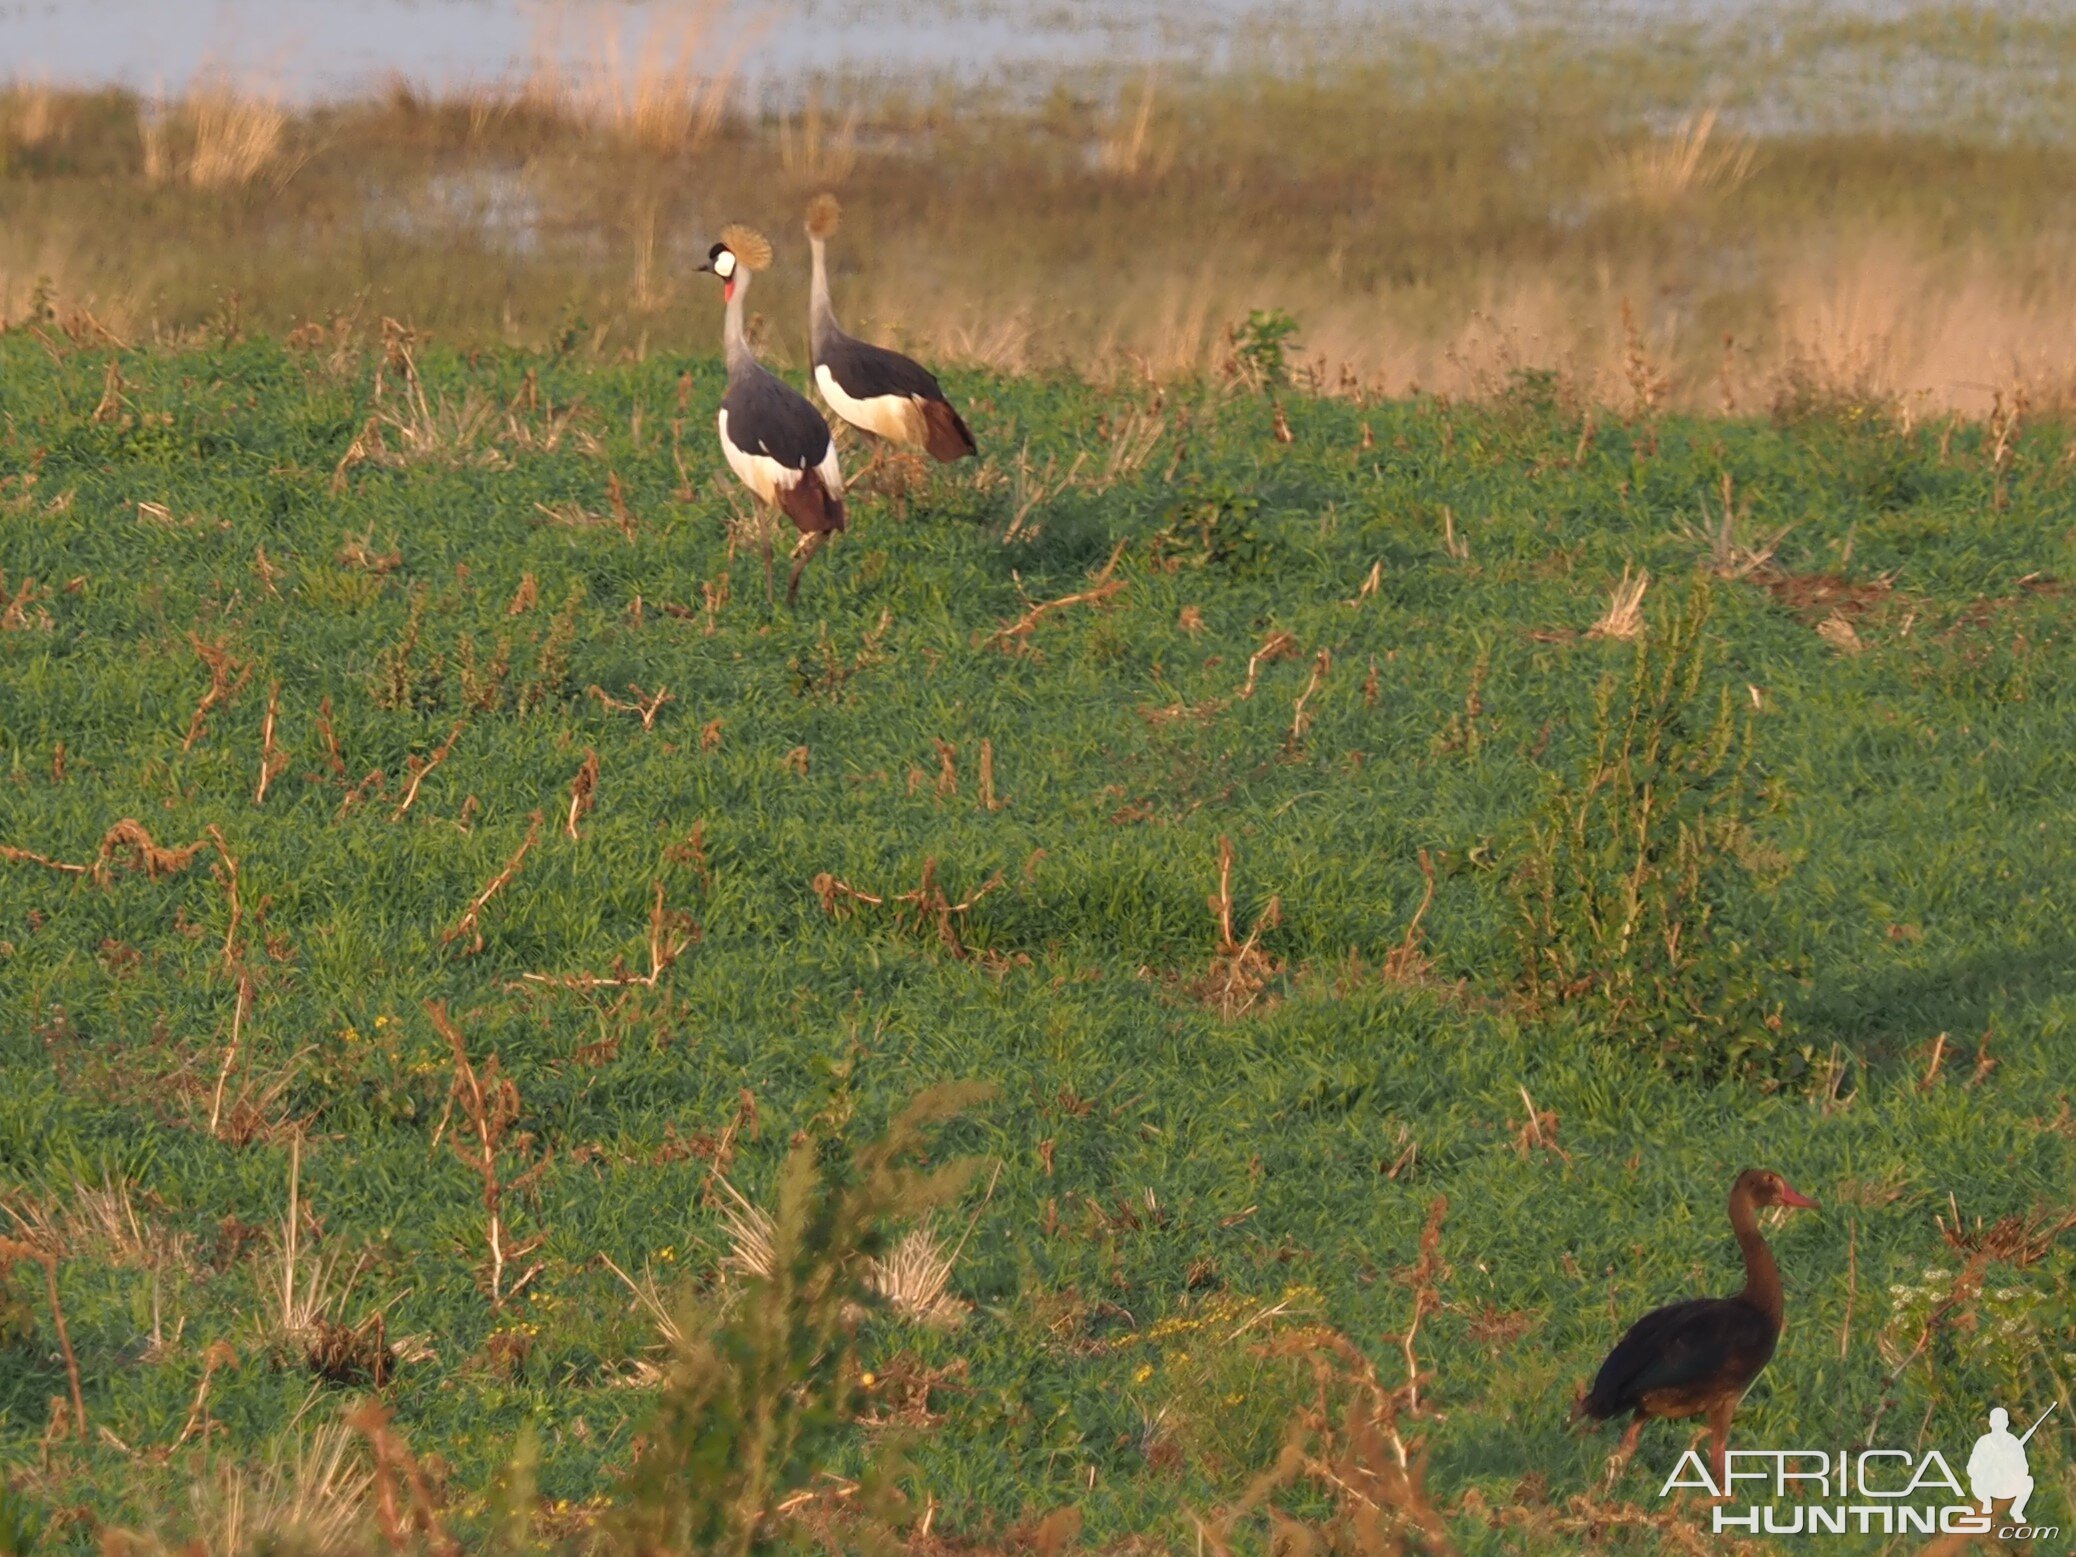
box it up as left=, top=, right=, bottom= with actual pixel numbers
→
left=700, top=226, right=845, bottom=604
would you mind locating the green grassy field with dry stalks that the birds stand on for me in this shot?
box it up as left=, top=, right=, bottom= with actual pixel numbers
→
left=0, top=332, right=2076, bottom=1551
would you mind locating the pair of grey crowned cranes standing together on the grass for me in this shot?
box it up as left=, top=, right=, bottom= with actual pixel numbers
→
left=700, top=195, right=976, bottom=604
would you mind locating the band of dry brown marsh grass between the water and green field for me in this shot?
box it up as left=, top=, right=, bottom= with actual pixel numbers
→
left=12, top=38, right=2076, bottom=417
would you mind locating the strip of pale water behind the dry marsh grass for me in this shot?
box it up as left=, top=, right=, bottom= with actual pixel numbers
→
left=0, top=0, right=1895, bottom=100
